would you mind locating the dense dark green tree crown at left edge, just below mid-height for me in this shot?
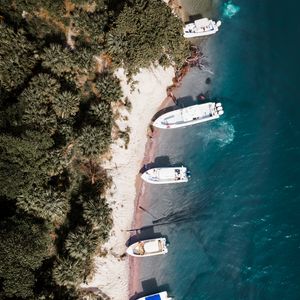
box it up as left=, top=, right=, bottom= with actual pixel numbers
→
left=0, top=132, right=53, bottom=198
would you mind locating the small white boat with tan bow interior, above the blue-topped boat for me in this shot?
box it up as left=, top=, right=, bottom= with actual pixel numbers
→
left=126, top=237, right=168, bottom=257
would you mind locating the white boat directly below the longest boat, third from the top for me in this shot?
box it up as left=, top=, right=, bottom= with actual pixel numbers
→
left=142, top=166, right=189, bottom=184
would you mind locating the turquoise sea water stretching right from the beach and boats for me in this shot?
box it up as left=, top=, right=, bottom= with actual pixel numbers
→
left=134, top=0, right=300, bottom=300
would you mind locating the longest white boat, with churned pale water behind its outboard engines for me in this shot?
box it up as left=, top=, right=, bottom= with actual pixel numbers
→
left=153, top=102, right=224, bottom=129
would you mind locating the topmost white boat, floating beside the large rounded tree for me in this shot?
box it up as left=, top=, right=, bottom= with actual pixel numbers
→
left=183, top=18, right=221, bottom=38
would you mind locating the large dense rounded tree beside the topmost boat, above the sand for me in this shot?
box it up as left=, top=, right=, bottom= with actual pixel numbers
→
left=107, top=0, right=188, bottom=72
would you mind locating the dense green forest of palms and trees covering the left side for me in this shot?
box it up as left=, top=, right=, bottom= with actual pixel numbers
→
left=0, top=0, right=188, bottom=299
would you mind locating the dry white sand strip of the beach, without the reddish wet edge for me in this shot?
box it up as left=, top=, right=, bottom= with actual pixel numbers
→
left=82, top=66, right=174, bottom=300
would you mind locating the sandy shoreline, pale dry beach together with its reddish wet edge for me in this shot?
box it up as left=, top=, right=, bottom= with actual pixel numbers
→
left=81, top=0, right=192, bottom=300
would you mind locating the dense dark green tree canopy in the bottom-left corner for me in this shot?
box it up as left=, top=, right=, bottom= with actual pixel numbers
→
left=0, top=216, right=51, bottom=299
